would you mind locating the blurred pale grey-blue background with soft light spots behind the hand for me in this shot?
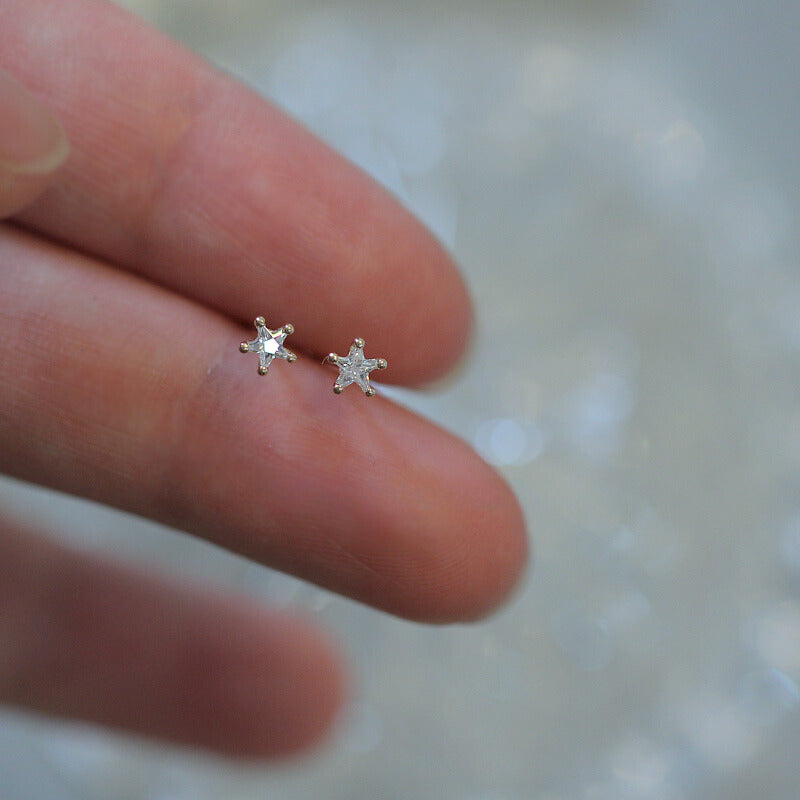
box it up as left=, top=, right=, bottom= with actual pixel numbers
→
left=0, top=0, right=800, bottom=800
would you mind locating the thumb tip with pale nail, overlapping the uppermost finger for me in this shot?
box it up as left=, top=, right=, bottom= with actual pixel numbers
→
left=0, top=72, right=69, bottom=175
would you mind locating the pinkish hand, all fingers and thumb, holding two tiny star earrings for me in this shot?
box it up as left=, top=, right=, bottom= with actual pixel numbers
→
left=0, top=0, right=527, bottom=758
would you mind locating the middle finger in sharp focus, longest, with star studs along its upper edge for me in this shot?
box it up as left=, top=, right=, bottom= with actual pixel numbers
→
left=0, top=227, right=525, bottom=621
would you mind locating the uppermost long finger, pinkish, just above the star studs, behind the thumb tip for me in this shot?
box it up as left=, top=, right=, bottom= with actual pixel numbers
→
left=0, top=0, right=471, bottom=383
